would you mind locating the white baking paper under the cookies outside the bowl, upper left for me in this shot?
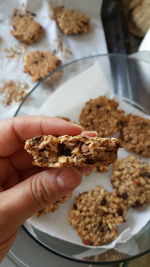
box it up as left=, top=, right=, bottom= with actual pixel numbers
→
left=0, top=0, right=107, bottom=119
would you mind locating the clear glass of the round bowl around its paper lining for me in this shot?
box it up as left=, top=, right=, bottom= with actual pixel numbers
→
left=15, top=55, right=150, bottom=265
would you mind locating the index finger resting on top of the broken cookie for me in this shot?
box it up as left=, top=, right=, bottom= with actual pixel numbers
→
left=0, top=116, right=82, bottom=157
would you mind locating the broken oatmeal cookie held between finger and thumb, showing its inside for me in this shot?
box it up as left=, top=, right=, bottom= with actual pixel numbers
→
left=25, top=135, right=120, bottom=168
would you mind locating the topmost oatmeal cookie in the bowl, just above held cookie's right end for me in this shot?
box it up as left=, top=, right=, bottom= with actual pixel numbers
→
left=80, top=96, right=124, bottom=137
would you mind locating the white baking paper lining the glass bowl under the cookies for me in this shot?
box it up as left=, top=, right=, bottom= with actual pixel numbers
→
left=27, top=62, right=150, bottom=252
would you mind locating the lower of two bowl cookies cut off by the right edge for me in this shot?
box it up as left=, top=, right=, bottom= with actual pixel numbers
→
left=111, top=156, right=150, bottom=207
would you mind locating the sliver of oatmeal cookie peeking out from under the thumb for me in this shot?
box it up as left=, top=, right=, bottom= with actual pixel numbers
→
left=36, top=194, right=72, bottom=217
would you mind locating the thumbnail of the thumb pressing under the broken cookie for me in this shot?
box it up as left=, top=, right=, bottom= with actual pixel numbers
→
left=57, top=168, right=81, bottom=189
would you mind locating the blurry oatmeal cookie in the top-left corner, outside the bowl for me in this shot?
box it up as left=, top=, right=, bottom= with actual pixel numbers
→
left=11, top=9, right=44, bottom=45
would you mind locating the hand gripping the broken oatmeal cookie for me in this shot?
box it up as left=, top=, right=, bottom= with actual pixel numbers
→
left=0, top=116, right=95, bottom=262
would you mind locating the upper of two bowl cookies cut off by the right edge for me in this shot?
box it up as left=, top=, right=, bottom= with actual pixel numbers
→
left=120, top=114, right=150, bottom=157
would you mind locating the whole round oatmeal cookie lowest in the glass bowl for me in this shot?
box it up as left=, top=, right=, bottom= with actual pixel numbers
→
left=69, top=186, right=127, bottom=246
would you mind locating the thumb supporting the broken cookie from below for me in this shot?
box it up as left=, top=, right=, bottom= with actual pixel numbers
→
left=0, top=168, right=81, bottom=230
